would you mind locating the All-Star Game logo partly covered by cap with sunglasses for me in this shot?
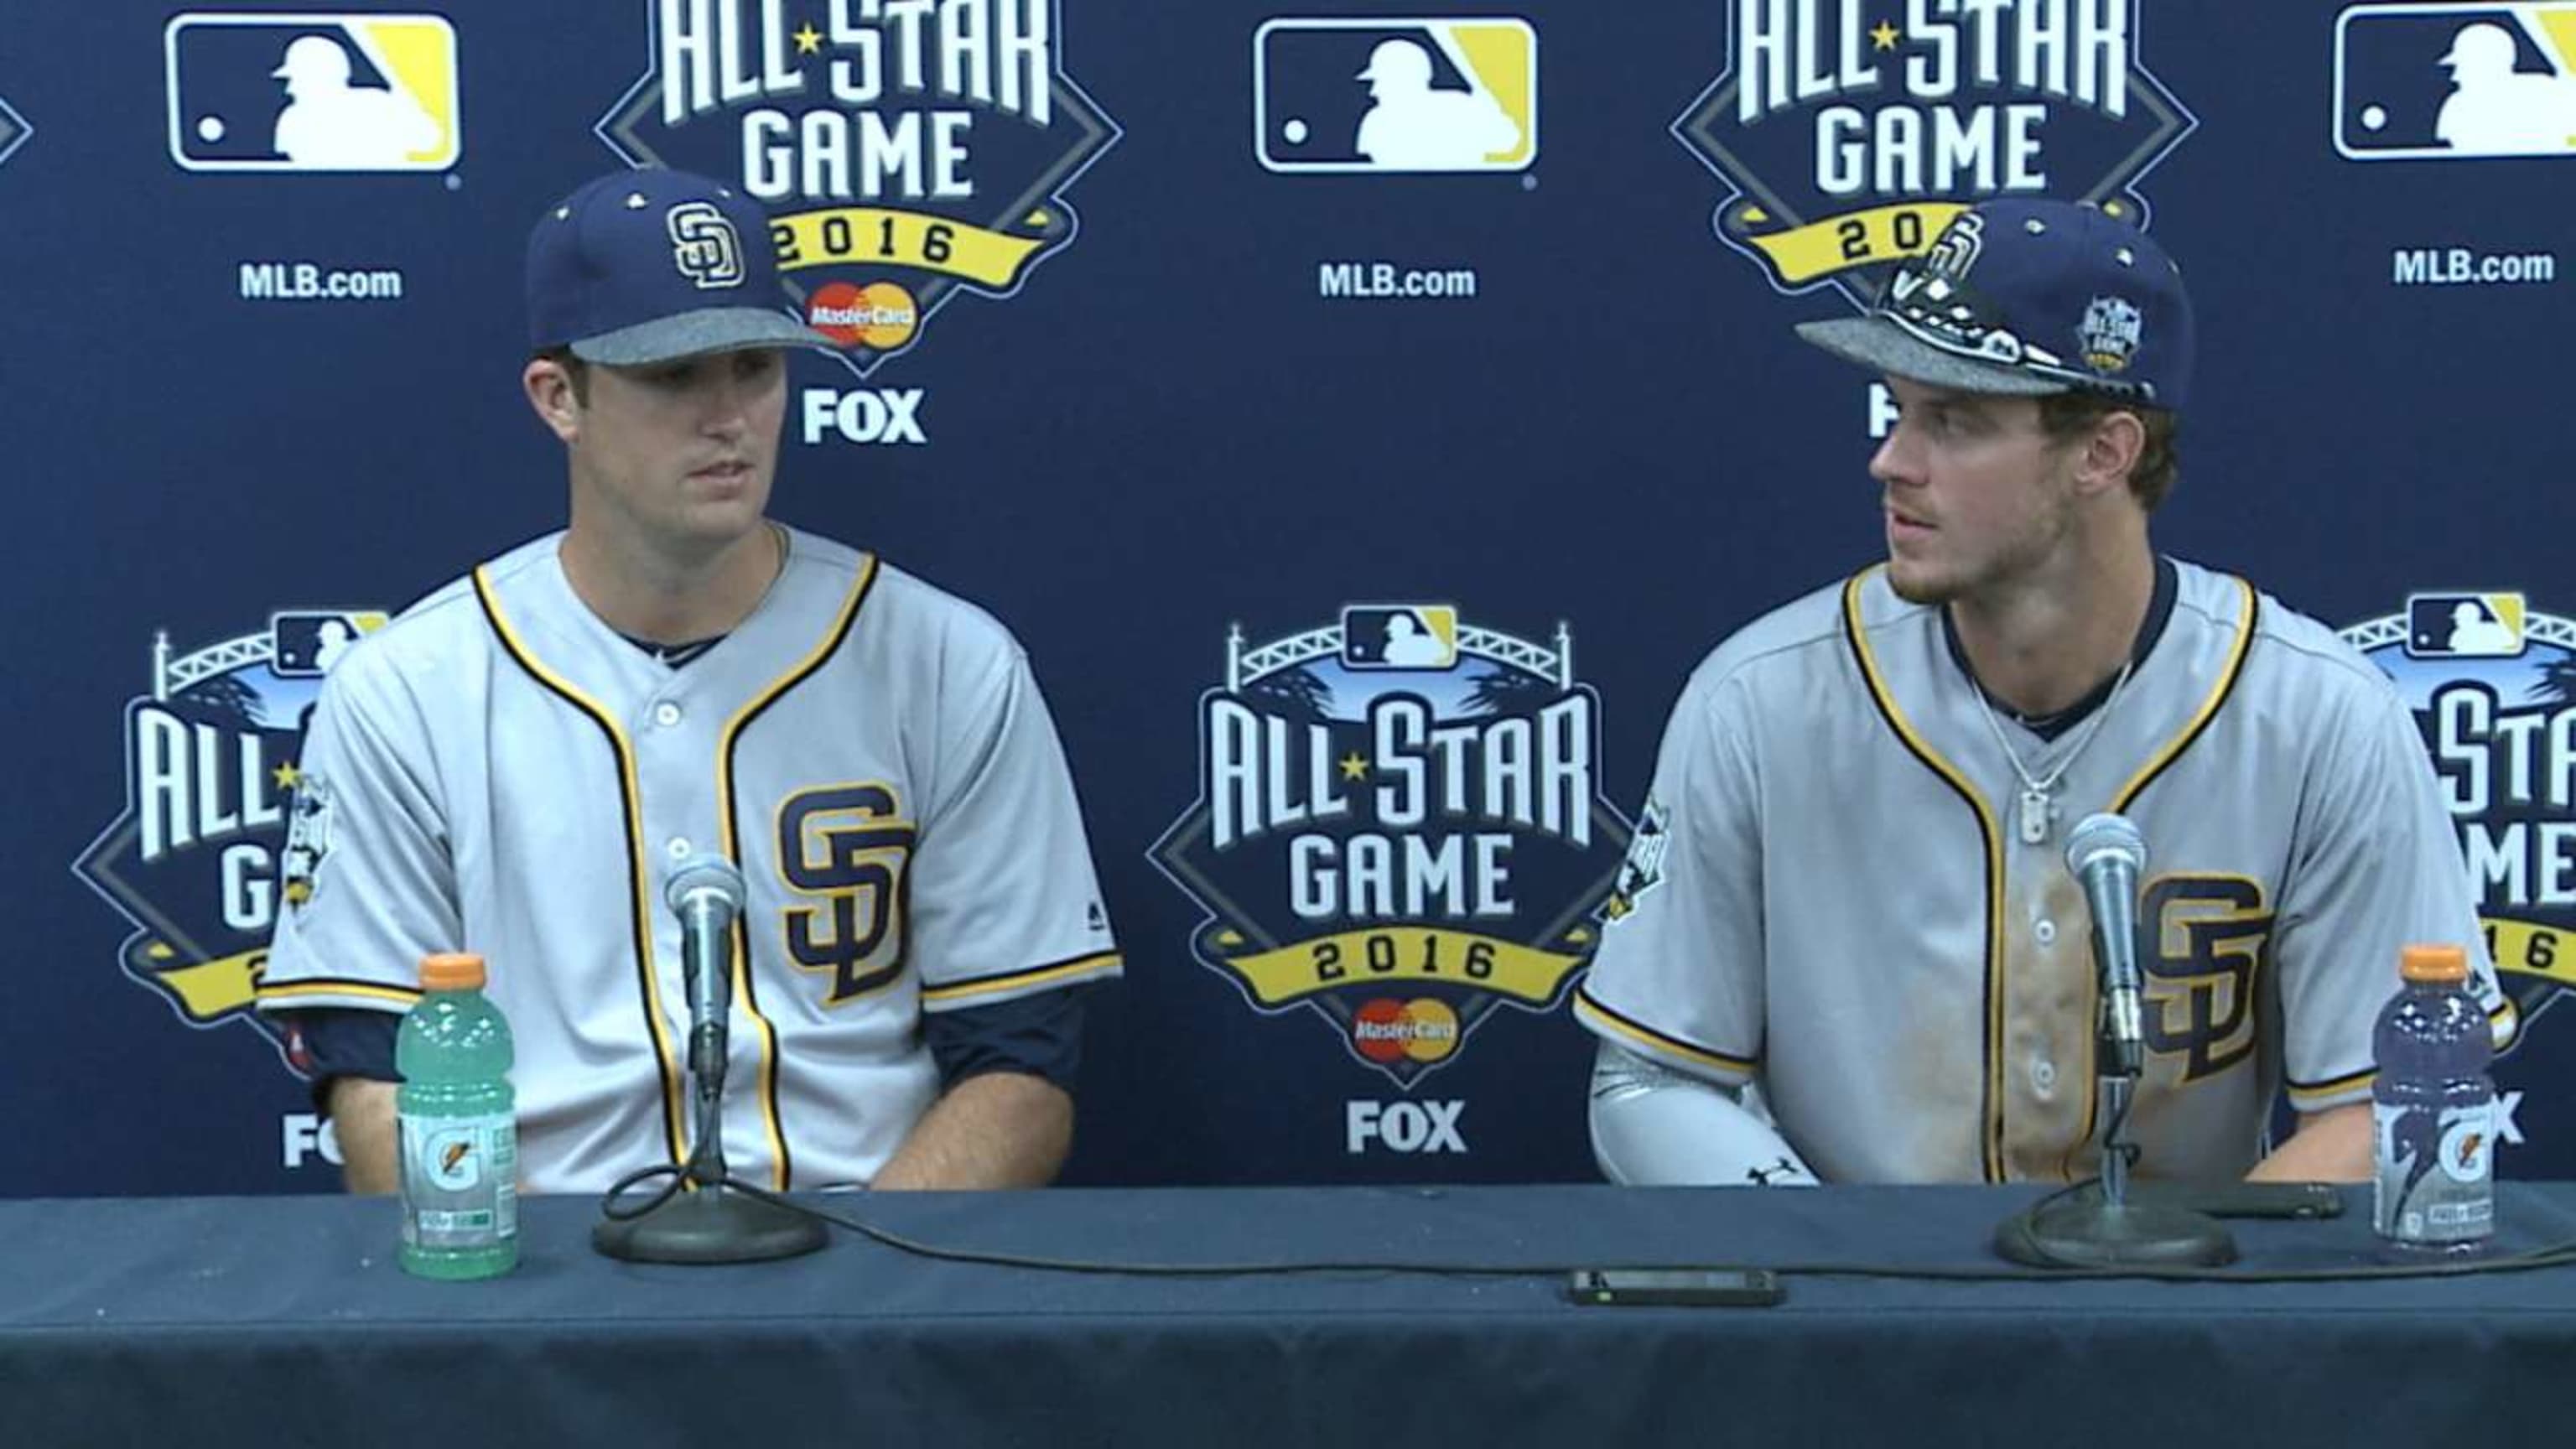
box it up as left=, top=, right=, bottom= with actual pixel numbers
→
left=1672, top=0, right=2197, bottom=309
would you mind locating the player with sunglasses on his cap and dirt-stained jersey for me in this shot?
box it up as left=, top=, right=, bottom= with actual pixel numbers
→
left=1576, top=199, right=2514, bottom=1183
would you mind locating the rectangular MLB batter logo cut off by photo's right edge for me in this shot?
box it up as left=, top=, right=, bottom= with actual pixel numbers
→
left=2334, top=3, right=2576, bottom=160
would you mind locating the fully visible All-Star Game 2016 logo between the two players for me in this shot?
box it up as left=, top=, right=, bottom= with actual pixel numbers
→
left=1151, top=603, right=1628, bottom=1085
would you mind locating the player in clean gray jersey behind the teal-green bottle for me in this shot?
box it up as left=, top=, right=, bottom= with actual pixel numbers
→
left=260, top=170, right=1120, bottom=1192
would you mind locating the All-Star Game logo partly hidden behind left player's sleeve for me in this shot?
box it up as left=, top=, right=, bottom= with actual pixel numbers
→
left=72, top=609, right=384, bottom=1062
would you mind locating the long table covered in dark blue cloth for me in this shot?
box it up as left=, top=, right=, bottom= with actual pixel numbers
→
left=0, top=1183, right=2576, bottom=1449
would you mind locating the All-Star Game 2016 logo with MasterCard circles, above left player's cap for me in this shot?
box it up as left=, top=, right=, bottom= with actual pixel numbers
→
left=598, top=0, right=1120, bottom=377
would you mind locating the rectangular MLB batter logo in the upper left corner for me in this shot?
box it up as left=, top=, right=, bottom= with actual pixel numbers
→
left=163, top=10, right=464, bottom=170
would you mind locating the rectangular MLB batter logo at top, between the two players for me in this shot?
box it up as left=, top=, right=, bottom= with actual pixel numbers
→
left=1252, top=15, right=1538, bottom=173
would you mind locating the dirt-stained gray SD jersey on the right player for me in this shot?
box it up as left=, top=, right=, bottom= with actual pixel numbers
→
left=1576, top=564, right=2514, bottom=1181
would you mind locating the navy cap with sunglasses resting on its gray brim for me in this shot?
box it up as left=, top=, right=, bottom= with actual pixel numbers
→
left=1798, top=196, right=2192, bottom=413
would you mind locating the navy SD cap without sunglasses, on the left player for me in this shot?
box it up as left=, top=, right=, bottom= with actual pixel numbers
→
left=528, top=170, right=832, bottom=366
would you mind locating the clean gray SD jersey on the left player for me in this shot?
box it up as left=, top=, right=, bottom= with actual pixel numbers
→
left=260, top=531, right=1120, bottom=1192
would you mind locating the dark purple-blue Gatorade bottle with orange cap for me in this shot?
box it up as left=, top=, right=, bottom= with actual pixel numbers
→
left=2370, top=946, right=2496, bottom=1253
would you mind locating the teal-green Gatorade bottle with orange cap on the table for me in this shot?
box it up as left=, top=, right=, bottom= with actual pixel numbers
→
left=394, top=954, right=517, bottom=1279
